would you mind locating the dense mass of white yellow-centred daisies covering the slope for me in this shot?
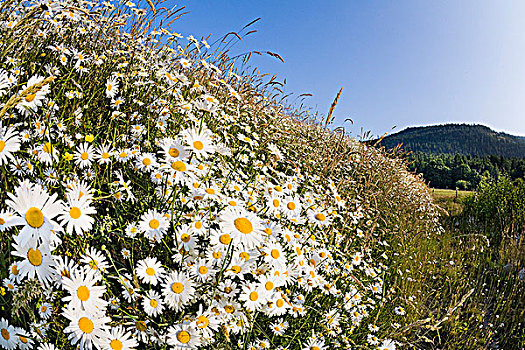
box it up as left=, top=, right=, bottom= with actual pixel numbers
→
left=0, top=0, right=420, bottom=350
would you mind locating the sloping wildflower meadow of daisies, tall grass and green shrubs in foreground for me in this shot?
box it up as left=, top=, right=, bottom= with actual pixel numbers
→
left=0, top=0, right=525, bottom=350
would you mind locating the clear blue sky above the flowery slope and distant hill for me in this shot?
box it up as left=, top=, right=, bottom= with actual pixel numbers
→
left=170, top=0, right=525, bottom=136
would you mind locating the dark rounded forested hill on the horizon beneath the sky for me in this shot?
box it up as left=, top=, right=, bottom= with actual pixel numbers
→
left=374, top=124, right=525, bottom=158
